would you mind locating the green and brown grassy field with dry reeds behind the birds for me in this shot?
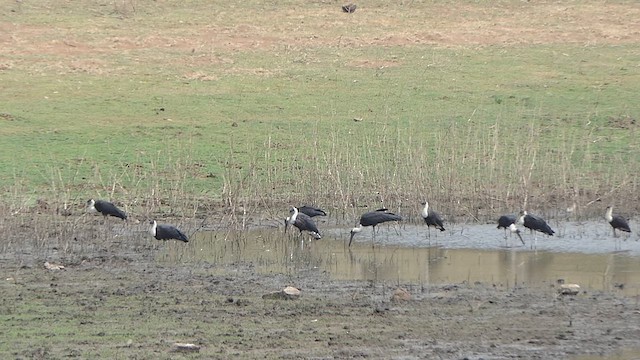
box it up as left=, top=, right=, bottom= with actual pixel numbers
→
left=0, top=0, right=640, bottom=219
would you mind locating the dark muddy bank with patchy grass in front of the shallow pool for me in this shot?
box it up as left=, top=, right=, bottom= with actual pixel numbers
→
left=0, top=215, right=640, bottom=359
